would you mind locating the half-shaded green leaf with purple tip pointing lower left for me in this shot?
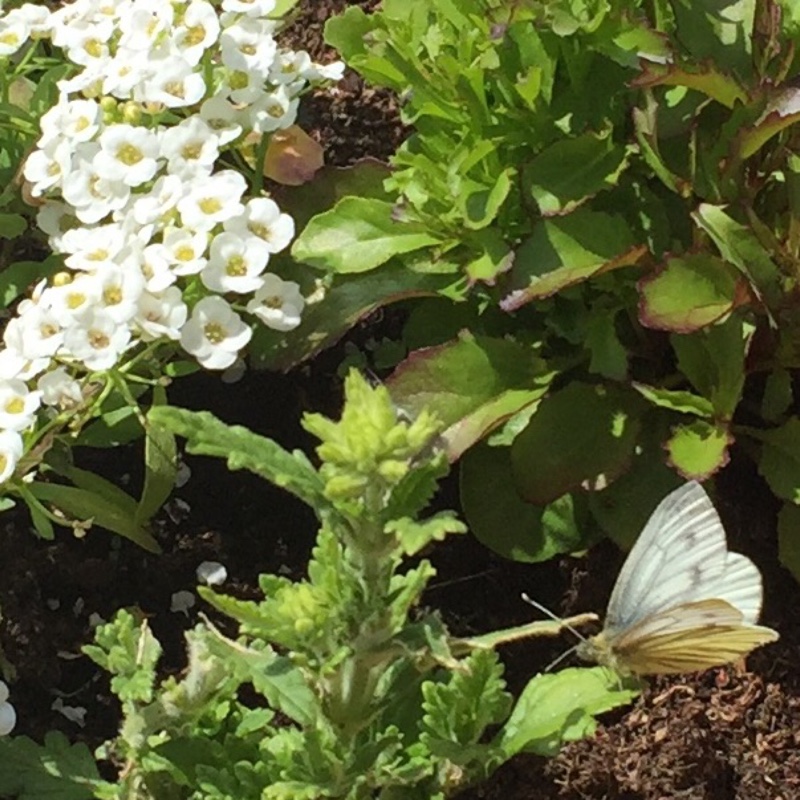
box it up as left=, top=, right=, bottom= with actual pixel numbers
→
left=500, top=208, right=644, bottom=311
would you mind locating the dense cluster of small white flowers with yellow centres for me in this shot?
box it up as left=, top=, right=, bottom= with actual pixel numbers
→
left=0, top=0, right=343, bottom=483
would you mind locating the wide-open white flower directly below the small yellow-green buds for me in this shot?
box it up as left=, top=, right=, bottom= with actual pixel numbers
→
left=93, top=124, right=159, bottom=186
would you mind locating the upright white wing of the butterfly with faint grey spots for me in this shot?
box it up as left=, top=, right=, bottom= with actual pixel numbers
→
left=605, top=481, right=761, bottom=638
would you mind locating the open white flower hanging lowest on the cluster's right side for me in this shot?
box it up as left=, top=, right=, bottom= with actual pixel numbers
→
left=181, top=296, right=253, bottom=369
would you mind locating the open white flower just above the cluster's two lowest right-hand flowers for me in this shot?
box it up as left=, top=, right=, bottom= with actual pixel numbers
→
left=200, top=232, right=269, bottom=294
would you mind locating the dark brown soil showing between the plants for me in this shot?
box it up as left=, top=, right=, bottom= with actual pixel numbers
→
left=0, top=0, right=800, bottom=800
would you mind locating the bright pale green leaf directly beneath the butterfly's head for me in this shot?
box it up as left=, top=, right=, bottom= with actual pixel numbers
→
left=495, top=667, right=639, bottom=758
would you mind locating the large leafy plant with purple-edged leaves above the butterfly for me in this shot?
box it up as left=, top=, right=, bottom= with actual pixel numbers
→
left=276, top=0, right=800, bottom=574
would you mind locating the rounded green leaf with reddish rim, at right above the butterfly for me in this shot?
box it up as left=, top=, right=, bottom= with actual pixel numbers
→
left=639, top=253, right=739, bottom=333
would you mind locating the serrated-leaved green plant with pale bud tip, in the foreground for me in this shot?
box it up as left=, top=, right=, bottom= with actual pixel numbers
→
left=0, top=372, right=632, bottom=800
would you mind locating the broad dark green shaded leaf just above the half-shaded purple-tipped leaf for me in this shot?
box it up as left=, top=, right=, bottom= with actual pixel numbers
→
left=523, top=128, right=628, bottom=217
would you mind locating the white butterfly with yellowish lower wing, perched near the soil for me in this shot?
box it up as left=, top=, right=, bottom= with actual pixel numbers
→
left=577, top=481, right=778, bottom=675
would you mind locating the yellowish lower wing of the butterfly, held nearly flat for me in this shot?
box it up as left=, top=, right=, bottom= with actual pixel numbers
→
left=607, top=598, right=778, bottom=675
